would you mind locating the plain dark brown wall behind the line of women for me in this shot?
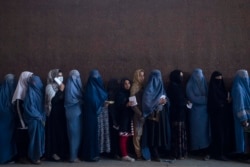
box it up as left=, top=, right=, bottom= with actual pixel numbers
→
left=0, top=0, right=250, bottom=86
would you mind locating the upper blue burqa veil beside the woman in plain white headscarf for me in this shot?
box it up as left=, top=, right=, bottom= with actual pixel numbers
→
left=23, top=75, right=45, bottom=120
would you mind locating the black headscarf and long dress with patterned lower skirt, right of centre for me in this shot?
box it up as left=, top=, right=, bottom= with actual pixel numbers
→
left=167, top=70, right=187, bottom=159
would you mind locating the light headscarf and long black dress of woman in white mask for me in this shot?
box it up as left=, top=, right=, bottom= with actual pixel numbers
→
left=45, top=69, right=69, bottom=160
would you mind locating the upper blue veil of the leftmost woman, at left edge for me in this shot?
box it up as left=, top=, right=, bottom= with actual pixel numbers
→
left=0, top=74, right=17, bottom=112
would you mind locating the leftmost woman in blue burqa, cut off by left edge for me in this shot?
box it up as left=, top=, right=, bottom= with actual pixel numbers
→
left=0, top=74, right=16, bottom=164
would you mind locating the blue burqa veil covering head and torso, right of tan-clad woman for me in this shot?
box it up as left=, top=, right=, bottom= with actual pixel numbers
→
left=142, top=70, right=166, bottom=117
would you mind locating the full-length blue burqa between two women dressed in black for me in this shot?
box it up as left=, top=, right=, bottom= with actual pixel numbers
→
left=186, top=68, right=210, bottom=150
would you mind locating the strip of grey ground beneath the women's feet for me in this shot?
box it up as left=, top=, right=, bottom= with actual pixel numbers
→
left=4, top=158, right=250, bottom=167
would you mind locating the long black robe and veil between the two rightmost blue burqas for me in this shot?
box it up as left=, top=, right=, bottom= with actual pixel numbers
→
left=208, top=71, right=229, bottom=159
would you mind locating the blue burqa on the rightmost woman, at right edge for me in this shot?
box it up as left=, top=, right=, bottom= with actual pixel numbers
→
left=232, top=70, right=250, bottom=153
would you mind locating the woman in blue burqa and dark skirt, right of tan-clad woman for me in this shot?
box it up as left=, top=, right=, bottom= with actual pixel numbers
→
left=142, top=70, right=170, bottom=161
